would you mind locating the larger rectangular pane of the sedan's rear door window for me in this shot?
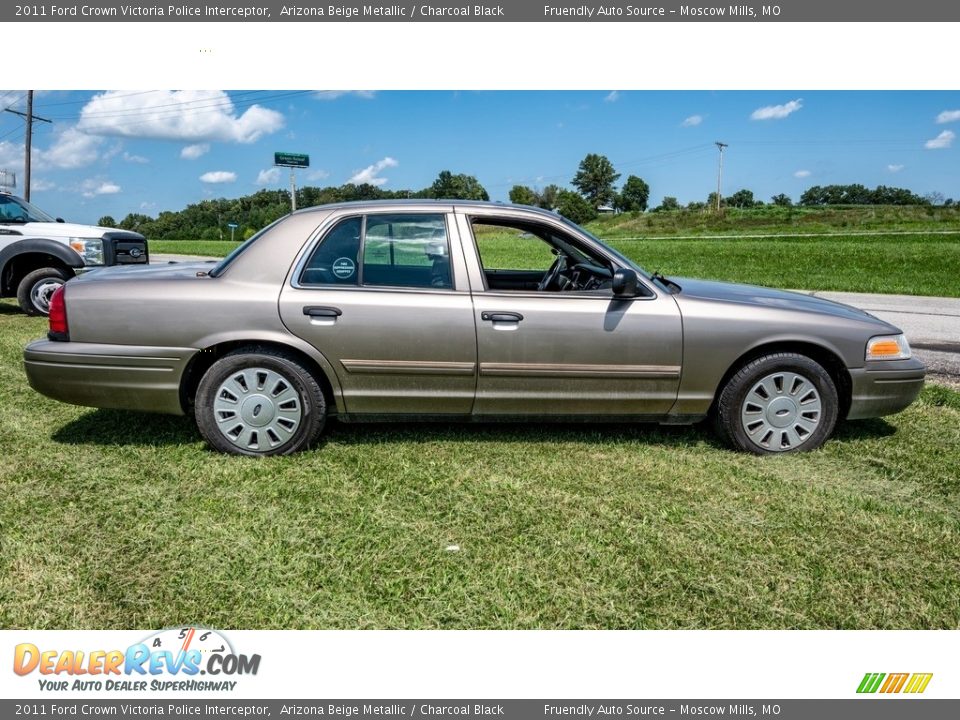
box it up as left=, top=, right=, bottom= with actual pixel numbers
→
left=362, top=214, right=453, bottom=290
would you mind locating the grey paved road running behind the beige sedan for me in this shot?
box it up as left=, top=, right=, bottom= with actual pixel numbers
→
left=151, top=254, right=960, bottom=385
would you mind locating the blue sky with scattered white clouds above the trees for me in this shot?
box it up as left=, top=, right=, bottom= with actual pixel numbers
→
left=0, top=90, right=960, bottom=222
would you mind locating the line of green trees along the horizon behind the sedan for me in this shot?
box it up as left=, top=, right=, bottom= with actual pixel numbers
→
left=99, top=153, right=955, bottom=240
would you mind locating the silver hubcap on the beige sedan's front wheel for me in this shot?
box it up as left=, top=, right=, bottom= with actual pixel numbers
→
left=740, top=372, right=823, bottom=452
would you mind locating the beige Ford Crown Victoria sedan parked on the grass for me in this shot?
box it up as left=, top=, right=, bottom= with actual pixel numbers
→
left=24, top=201, right=925, bottom=455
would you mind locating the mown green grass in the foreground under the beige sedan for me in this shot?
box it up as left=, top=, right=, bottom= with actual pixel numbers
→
left=0, top=301, right=960, bottom=629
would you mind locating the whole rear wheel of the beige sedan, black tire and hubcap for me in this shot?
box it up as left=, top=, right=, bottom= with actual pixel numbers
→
left=194, top=347, right=327, bottom=457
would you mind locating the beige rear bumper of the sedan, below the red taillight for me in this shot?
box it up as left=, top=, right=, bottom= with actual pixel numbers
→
left=23, top=340, right=197, bottom=415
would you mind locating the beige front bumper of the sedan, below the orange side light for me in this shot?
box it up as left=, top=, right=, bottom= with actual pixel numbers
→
left=847, top=358, right=927, bottom=420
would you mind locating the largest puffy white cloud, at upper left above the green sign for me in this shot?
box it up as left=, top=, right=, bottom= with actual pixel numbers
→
left=77, top=90, right=284, bottom=143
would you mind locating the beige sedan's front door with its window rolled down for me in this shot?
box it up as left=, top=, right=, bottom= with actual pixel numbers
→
left=460, top=217, right=683, bottom=416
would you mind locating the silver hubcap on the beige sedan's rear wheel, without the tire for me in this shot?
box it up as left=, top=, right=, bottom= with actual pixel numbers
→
left=213, top=368, right=303, bottom=451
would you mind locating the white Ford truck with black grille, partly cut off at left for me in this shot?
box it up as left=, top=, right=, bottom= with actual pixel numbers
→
left=0, top=192, right=149, bottom=315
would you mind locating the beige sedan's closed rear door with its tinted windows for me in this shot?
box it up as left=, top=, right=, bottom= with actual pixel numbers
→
left=280, top=208, right=477, bottom=415
